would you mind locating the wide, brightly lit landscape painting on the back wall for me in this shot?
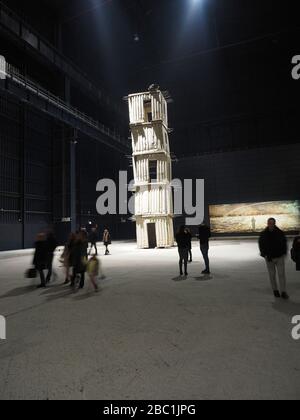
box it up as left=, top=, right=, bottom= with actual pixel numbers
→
left=210, top=201, right=300, bottom=233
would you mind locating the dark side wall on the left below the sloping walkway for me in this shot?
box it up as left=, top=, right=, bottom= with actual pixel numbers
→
left=0, top=95, right=133, bottom=251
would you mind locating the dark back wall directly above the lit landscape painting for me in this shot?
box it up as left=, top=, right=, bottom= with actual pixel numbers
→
left=173, top=144, right=300, bottom=225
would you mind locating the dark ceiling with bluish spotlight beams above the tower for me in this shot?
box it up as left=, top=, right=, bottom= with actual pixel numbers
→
left=1, top=0, right=300, bottom=156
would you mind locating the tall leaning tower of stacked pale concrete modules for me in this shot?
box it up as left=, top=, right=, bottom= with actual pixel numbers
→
left=128, top=85, right=174, bottom=248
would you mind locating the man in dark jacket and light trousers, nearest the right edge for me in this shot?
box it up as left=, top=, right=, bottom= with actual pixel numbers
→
left=259, top=217, right=289, bottom=299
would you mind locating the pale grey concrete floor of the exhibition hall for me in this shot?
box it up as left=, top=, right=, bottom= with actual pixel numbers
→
left=0, top=241, right=300, bottom=400
